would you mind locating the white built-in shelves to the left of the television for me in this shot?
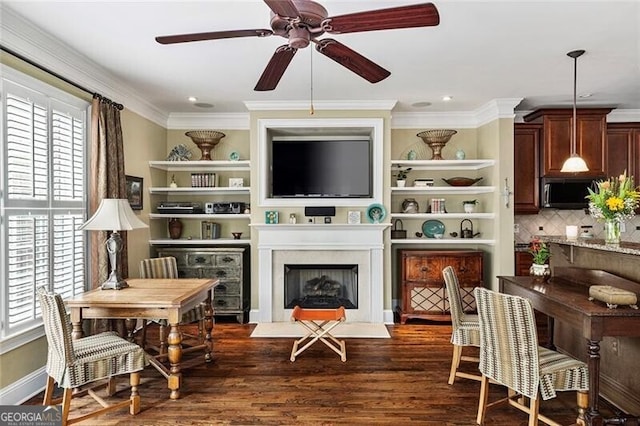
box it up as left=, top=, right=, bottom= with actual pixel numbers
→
left=148, top=160, right=251, bottom=246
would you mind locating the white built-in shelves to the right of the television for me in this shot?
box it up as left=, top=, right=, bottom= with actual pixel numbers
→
left=390, top=159, right=496, bottom=246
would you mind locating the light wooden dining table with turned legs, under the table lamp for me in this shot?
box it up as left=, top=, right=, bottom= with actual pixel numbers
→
left=65, top=278, right=218, bottom=399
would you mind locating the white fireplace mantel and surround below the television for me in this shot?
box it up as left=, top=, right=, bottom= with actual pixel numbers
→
left=250, top=223, right=390, bottom=323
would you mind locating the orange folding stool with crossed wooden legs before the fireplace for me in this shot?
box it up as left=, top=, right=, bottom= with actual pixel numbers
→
left=291, top=306, right=347, bottom=362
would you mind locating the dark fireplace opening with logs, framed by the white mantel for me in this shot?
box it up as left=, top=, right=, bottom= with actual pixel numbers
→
left=284, top=265, right=358, bottom=309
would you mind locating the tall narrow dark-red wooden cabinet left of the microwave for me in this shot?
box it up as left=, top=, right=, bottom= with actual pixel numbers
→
left=513, top=123, right=542, bottom=214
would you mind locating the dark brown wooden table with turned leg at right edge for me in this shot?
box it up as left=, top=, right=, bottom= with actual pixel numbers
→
left=498, top=267, right=640, bottom=426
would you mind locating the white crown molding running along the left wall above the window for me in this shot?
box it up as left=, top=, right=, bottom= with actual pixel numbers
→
left=0, top=3, right=168, bottom=127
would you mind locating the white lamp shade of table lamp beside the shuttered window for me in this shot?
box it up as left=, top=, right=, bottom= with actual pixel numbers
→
left=78, top=198, right=148, bottom=231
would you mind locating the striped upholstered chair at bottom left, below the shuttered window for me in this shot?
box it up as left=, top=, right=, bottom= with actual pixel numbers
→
left=38, top=287, right=149, bottom=425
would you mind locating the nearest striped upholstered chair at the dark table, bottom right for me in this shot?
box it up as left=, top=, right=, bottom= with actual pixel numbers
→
left=474, top=287, right=589, bottom=426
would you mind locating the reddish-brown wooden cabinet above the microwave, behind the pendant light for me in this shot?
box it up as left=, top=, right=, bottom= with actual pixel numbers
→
left=524, top=108, right=611, bottom=177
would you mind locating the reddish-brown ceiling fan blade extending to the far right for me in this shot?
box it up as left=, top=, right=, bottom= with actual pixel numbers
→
left=321, top=3, right=440, bottom=34
